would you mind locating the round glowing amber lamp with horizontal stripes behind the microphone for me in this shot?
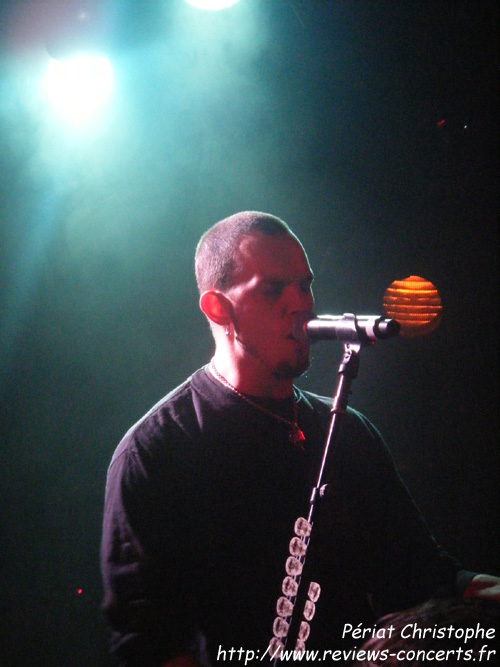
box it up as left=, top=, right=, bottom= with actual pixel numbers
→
left=383, top=276, right=442, bottom=338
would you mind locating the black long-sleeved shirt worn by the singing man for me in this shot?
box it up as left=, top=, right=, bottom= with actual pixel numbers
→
left=102, top=369, right=468, bottom=667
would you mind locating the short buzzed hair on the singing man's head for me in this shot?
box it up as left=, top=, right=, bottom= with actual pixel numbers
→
left=195, top=211, right=296, bottom=294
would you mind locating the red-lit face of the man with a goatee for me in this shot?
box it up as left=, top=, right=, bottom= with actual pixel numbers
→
left=225, top=232, right=314, bottom=380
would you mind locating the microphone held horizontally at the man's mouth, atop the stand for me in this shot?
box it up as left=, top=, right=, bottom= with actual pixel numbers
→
left=293, top=313, right=401, bottom=343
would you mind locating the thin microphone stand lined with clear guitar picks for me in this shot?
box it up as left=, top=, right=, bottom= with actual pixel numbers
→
left=268, top=326, right=373, bottom=665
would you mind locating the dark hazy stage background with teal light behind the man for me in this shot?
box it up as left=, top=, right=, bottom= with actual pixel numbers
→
left=0, top=0, right=500, bottom=667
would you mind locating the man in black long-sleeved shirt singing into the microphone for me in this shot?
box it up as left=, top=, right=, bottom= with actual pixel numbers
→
left=102, top=212, right=498, bottom=667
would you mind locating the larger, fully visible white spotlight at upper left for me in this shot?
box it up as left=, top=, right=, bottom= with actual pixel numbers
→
left=43, top=54, right=113, bottom=123
